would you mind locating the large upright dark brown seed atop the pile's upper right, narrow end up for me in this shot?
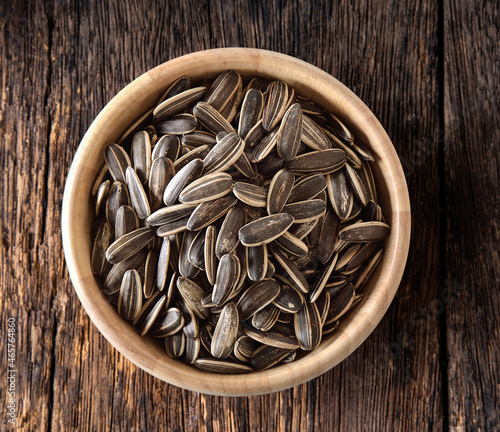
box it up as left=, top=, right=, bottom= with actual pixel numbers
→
left=276, top=103, right=302, bottom=161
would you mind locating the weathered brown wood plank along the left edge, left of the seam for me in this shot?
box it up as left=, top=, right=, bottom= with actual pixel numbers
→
left=0, top=2, right=56, bottom=430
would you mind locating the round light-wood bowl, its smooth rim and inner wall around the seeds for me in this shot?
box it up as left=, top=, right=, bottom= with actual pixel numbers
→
left=62, top=48, right=410, bottom=396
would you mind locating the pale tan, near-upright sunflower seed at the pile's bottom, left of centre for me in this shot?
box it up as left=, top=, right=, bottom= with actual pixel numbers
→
left=210, top=303, right=239, bottom=359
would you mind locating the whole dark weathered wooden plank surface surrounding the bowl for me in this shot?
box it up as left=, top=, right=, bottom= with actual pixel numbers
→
left=0, top=0, right=500, bottom=432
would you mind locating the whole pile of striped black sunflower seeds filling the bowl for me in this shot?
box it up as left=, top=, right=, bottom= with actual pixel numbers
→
left=91, top=71, right=390, bottom=373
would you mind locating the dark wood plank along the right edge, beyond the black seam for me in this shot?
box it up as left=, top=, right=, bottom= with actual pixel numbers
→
left=442, top=0, right=500, bottom=432
